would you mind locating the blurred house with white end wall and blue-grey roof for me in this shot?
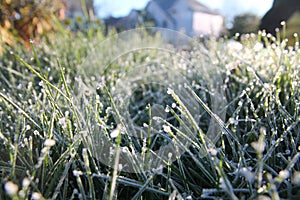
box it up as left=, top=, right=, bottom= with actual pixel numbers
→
left=105, top=0, right=224, bottom=37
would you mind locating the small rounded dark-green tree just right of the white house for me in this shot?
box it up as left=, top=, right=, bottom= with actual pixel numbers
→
left=229, top=13, right=260, bottom=36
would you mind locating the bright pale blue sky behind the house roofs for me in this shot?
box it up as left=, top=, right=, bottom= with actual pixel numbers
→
left=94, top=0, right=273, bottom=22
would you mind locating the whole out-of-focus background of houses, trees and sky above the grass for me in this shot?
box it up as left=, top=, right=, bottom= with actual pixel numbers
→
left=0, top=0, right=300, bottom=46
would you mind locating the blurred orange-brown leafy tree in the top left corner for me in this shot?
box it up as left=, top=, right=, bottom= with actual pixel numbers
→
left=0, top=0, right=63, bottom=52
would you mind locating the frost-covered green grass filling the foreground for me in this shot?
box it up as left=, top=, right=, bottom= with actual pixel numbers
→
left=0, top=27, right=300, bottom=199
